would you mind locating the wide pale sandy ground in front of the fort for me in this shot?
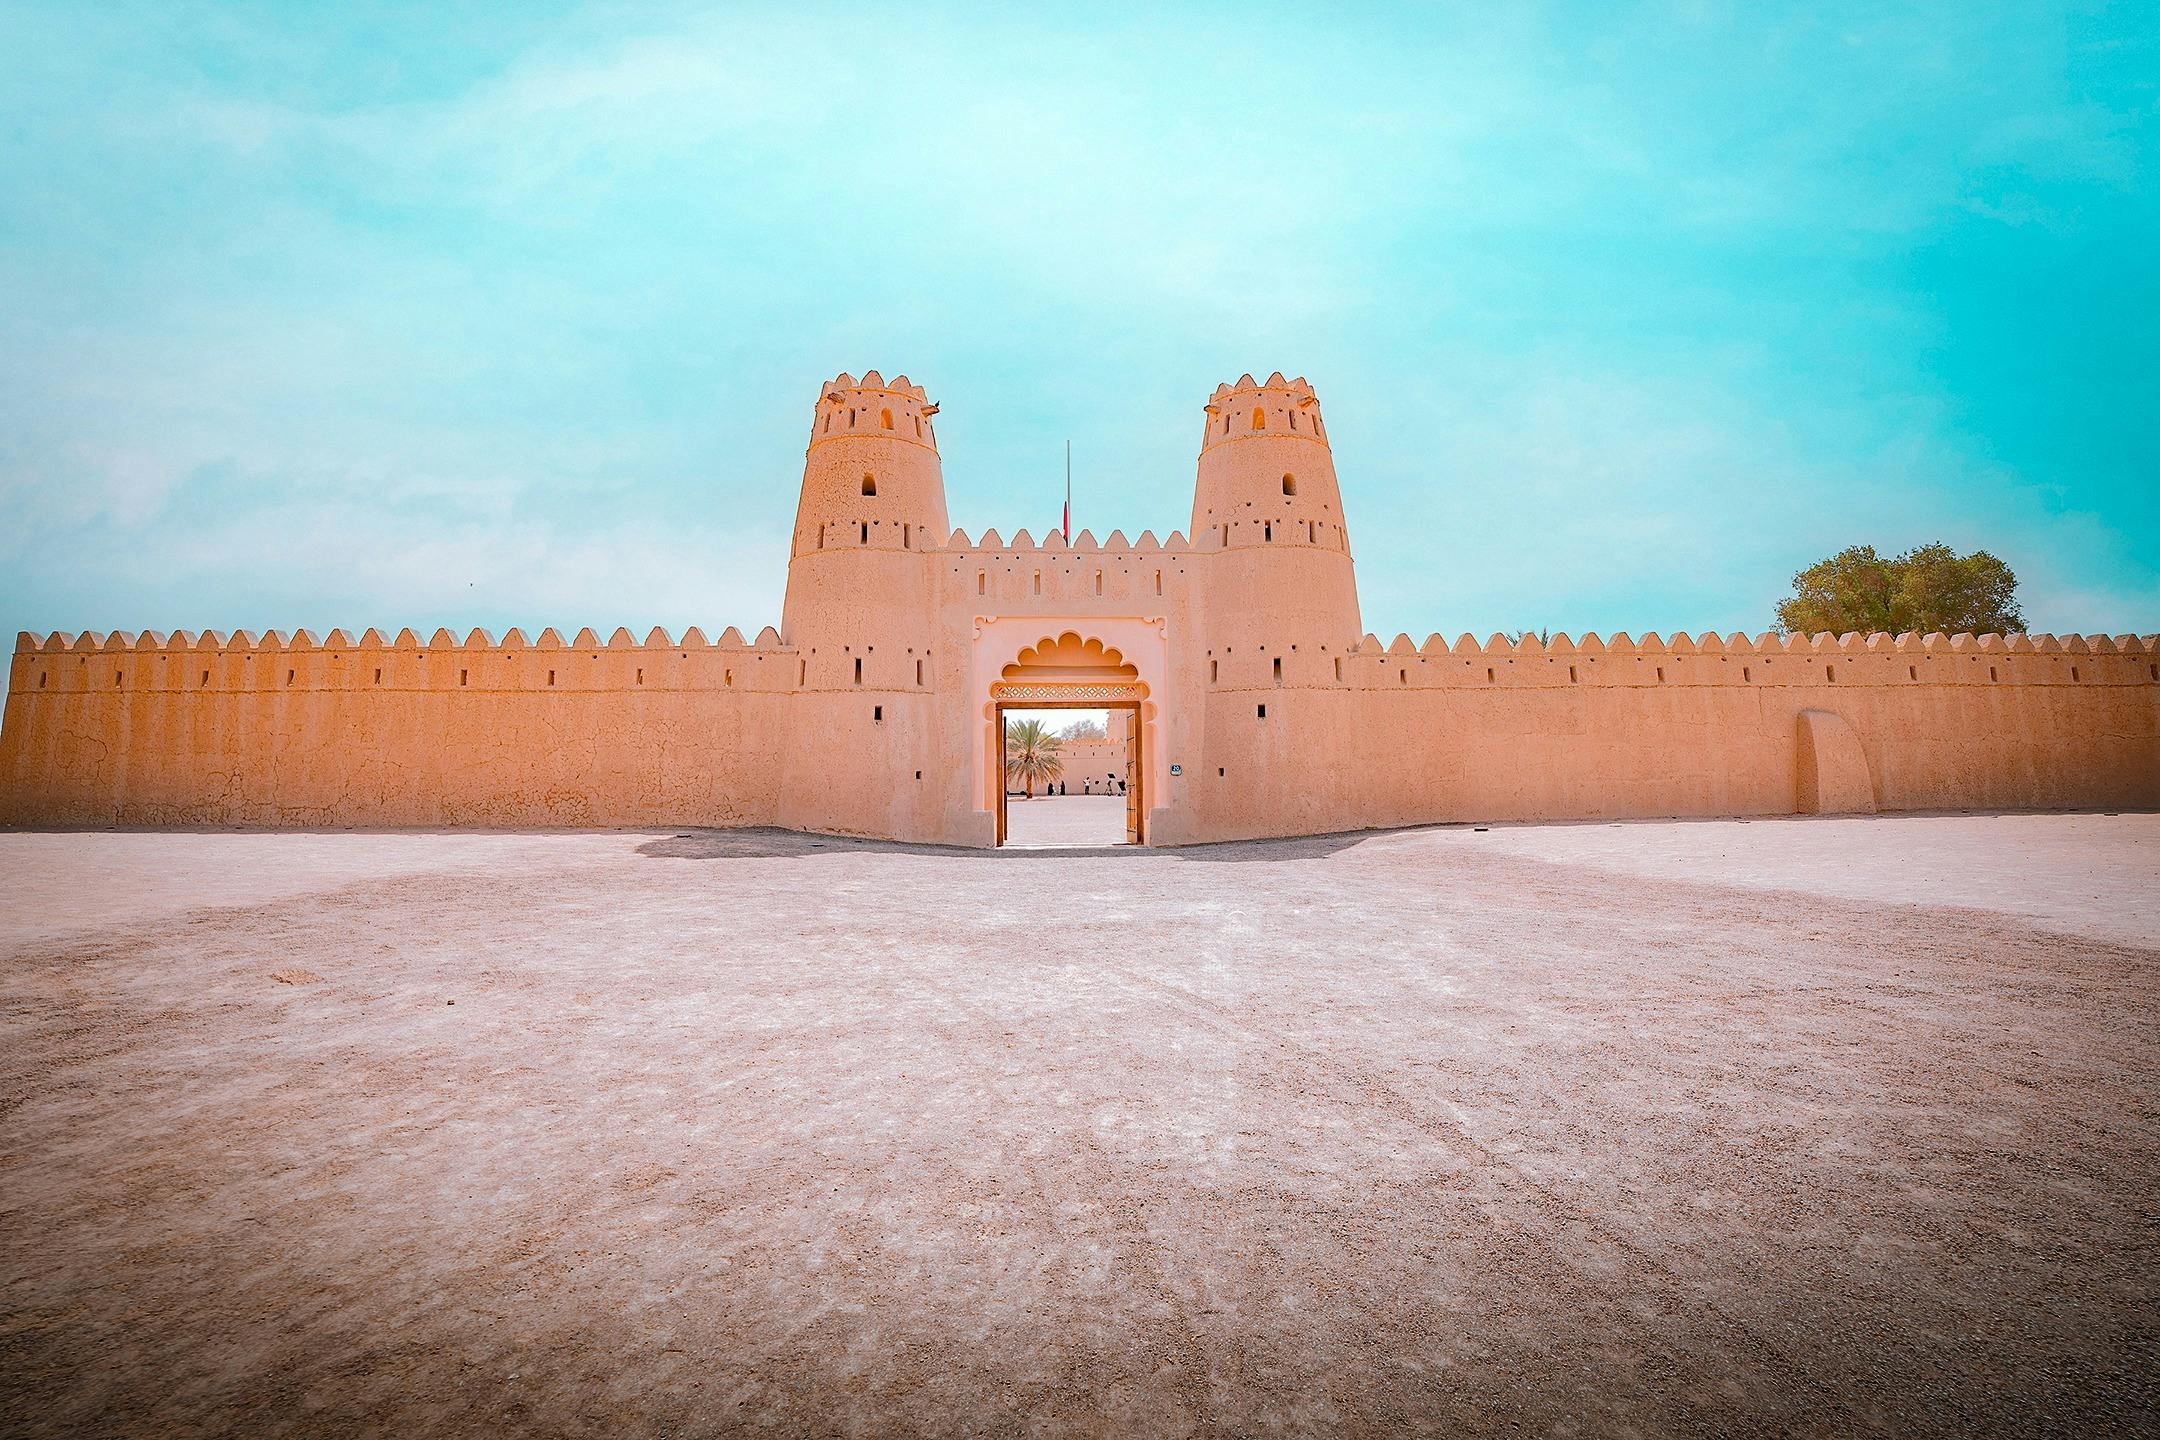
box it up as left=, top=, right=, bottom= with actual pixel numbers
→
left=0, top=816, right=2160, bottom=1436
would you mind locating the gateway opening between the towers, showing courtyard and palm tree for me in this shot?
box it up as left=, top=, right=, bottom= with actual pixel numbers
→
left=998, top=702, right=1143, bottom=851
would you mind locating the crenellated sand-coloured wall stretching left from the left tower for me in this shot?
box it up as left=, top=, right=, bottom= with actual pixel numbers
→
left=0, top=630, right=797, bottom=827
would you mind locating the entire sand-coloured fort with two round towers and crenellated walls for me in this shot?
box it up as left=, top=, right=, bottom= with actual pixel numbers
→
left=0, top=371, right=2160, bottom=846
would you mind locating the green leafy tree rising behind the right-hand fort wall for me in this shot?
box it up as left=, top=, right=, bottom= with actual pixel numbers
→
left=1778, top=544, right=2024, bottom=635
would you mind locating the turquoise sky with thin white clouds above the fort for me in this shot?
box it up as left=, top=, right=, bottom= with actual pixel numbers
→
left=0, top=2, right=2160, bottom=690
